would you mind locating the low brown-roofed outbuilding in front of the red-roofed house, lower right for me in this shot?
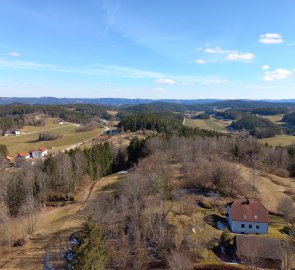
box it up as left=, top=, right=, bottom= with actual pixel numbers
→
left=234, top=235, right=283, bottom=269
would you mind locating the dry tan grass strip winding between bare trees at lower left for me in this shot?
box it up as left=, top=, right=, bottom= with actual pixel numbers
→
left=0, top=175, right=119, bottom=270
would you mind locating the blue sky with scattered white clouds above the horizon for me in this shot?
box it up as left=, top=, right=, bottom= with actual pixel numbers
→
left=0, top=0, right=295, bottom=99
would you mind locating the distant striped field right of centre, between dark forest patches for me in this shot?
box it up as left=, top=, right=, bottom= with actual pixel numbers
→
left=185, top=118, right=228, bottom=132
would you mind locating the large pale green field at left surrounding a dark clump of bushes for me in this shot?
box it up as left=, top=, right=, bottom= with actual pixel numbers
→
left=0, top=123, right=103, bottom=156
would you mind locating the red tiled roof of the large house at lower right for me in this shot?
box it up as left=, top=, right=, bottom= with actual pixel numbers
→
left=228, top=199, right=269, bottom=223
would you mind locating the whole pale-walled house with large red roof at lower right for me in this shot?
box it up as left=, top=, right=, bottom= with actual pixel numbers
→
left=226, top=199, right=269, bottom=234
